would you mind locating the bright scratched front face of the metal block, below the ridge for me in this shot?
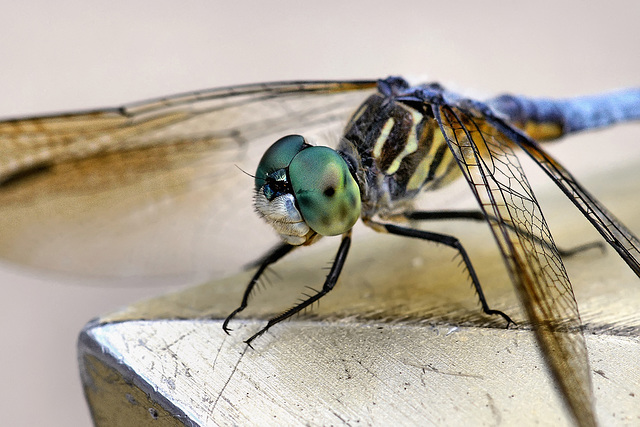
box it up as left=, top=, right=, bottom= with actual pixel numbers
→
left=81, top=321, right=640, bottom=425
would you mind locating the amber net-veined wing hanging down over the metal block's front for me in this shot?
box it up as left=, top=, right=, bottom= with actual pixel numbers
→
left=434, top=105, right=595, bottom=425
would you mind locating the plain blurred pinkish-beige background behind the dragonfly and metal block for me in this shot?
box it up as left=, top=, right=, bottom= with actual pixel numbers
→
left=0, top=1, right=640, bottom=425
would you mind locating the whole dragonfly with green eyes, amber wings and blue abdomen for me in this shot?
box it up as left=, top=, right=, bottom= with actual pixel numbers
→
left=0, top=77, right=640, bottom=425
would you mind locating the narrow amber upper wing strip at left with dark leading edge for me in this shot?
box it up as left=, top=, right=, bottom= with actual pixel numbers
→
left=0, top=80, right=376, bottom=184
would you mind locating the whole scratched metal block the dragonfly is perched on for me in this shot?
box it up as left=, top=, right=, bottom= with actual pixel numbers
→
left=81, top=160, right=640, bottom=425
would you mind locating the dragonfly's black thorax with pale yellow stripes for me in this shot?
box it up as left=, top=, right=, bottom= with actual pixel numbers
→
left=338, top=91, right=460, bottom=219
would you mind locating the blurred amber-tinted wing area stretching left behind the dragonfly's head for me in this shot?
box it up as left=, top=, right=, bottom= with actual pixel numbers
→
left=0, top=81, right=375, bottom=282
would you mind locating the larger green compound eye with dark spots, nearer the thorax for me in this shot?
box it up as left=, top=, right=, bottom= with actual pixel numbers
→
left=289, top=147, right=360, bottom=236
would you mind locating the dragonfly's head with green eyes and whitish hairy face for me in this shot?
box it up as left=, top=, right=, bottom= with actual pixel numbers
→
left=254, top=135, right=360, bottom=245
